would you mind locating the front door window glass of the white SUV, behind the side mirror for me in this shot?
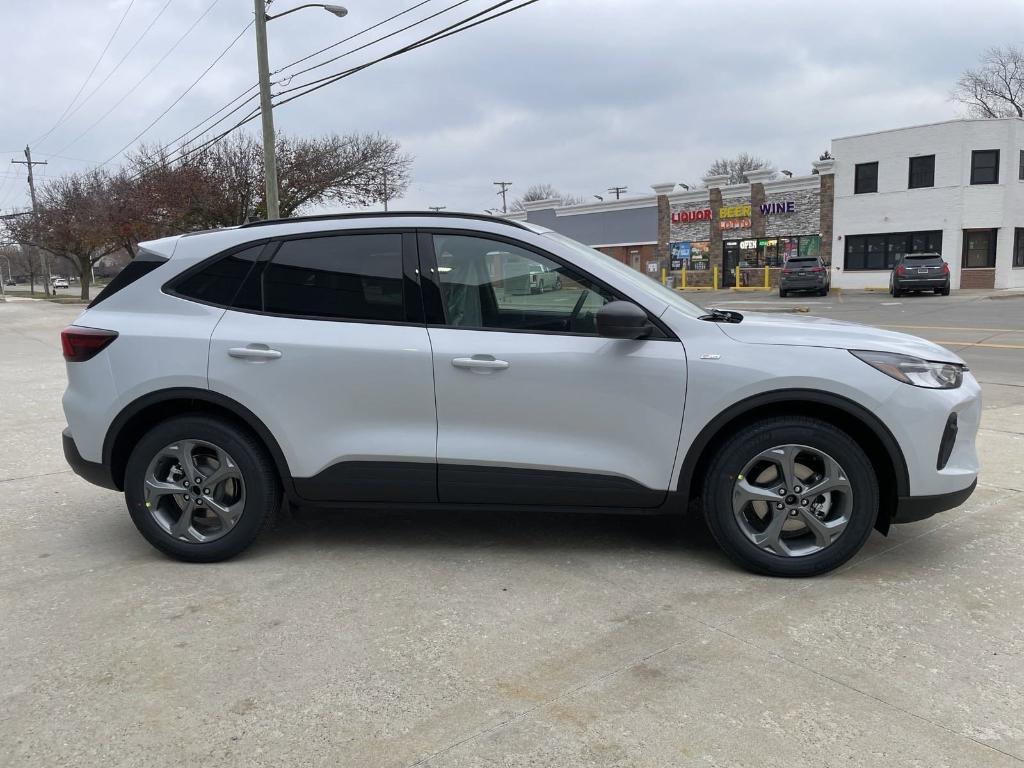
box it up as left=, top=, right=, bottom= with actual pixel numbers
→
left=434, top=234, right=618, bottom=335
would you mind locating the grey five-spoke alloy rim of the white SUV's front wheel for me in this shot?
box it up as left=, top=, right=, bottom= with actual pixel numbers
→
left=732, top=444, right=853, bottom=557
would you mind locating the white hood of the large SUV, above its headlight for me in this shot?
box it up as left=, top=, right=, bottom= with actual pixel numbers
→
left=719, top=312, right=964, bottom=365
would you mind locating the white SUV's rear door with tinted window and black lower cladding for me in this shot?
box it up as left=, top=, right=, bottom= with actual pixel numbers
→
left=203, top=230, right=436, bottom=502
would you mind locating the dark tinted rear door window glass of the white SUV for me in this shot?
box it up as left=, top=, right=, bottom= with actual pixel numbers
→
left=263, top=234, right=406, bottom=322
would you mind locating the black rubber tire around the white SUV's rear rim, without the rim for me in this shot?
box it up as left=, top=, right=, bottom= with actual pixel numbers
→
left=125, top=415, right=281, bottom=562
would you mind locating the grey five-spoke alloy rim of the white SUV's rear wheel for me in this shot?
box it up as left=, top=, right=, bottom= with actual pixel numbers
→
left=144, top=439, right=246, bottom=544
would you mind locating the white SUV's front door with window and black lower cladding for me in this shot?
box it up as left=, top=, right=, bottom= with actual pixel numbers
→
left=419, top=231, right=686, bottom=507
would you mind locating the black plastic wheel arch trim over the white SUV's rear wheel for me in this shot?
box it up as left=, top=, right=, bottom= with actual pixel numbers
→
left=103, top=387, right=294, bottom=497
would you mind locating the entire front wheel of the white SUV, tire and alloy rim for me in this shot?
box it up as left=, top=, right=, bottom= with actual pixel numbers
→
left=703, top=417, right=879, bottom=577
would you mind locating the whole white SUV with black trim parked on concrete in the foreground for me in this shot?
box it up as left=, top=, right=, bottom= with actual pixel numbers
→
left=61, top=213, right=981, bottom=575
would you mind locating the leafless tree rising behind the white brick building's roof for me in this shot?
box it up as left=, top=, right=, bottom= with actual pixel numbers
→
left=951, top=45, right=1024, bottom=118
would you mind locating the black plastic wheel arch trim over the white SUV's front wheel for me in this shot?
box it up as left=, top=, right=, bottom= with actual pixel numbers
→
left=677, top=389, right=910, bottom=532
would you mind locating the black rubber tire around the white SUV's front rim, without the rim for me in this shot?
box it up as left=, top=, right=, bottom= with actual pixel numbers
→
left=703, top=417, right=879, bottom=577
